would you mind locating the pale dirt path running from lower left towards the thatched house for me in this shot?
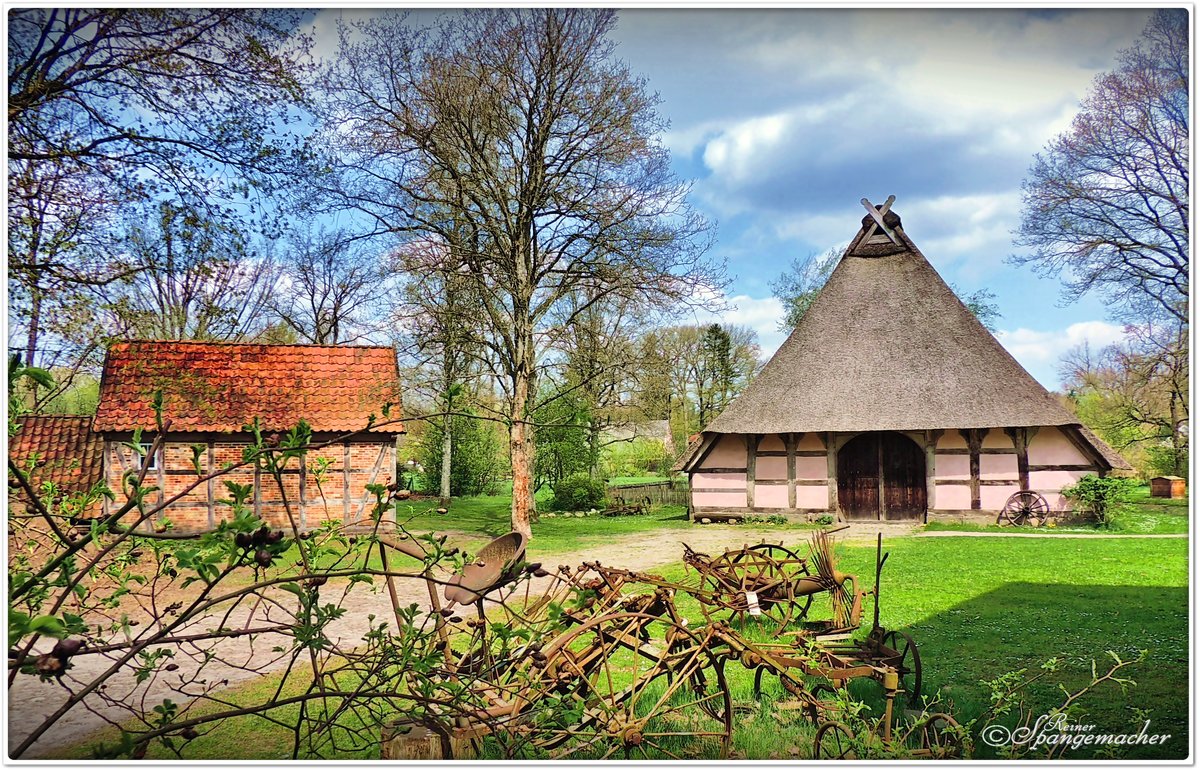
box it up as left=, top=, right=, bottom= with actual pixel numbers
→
left=8, top=524, right=914, bottom=758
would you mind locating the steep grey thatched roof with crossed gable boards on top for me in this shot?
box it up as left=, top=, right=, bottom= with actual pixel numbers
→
left=706, top=205, right=1099, bottom=434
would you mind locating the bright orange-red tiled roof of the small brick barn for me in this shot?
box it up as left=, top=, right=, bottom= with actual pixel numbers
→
left=91, top=341, right=404, bottom=434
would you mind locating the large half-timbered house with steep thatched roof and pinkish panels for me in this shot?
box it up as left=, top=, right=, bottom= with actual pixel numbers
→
left=677, top=202, right=1129, bottom=521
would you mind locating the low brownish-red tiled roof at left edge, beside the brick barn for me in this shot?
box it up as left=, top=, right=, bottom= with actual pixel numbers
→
left=8, top=416, right=103, bottom=492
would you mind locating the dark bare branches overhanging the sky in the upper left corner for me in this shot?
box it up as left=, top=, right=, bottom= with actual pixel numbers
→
left=7, top=8, right=308, bottom=407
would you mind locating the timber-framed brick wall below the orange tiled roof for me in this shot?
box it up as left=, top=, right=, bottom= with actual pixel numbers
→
left=103, top=435, right=396, bottom=532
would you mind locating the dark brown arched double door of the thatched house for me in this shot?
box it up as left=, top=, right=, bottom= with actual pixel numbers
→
left=838, top=431, right=926, bottom=520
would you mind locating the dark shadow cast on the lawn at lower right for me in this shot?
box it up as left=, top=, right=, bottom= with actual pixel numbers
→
left=884, top=582, right=1189, bottom=759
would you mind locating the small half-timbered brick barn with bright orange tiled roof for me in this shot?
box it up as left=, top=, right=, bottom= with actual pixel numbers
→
left=91, top=341, right=403, bottom=532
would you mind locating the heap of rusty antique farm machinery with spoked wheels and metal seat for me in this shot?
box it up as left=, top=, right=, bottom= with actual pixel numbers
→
left=379, top=531, right=950, bottom=759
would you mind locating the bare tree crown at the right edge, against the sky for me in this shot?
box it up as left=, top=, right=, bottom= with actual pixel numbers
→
left=1013, top=8, right=1189, bottom=323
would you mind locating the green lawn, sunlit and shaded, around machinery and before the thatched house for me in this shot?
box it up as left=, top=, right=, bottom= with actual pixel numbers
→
left=49, top=528, right=1189, bottom=759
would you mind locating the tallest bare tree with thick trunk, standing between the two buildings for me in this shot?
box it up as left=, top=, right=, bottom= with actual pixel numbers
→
left=323, top=8, right=712, bottom=534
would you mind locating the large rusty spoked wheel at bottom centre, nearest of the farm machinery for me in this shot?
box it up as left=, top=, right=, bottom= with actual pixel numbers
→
left=517, top=612, right=733, bottom=760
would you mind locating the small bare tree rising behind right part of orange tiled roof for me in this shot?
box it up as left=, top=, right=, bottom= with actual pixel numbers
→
left=268, top=231, right=386, bottom=345
